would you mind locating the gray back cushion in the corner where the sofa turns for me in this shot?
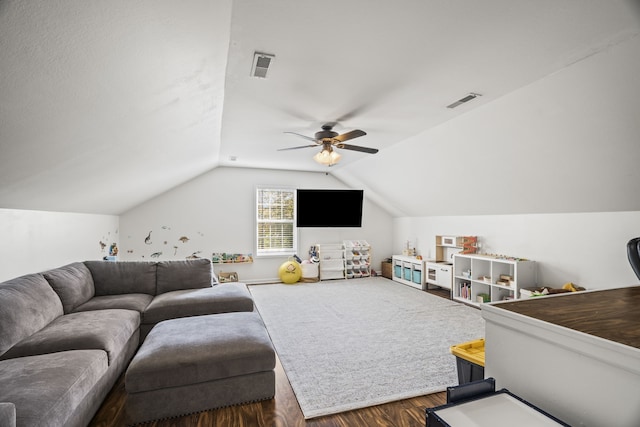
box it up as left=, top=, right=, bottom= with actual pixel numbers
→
left=43, top=262, right=95, bottom=313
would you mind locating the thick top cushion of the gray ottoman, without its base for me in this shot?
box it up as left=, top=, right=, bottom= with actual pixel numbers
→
left=125, top=312, right=276, bottom=393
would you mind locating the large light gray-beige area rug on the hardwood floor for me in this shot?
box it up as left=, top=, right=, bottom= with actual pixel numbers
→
left=249, top=277, right=484, bottom=419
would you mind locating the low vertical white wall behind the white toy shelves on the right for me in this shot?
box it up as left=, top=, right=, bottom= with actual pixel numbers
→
left=394, top=212, right=640, bottom=289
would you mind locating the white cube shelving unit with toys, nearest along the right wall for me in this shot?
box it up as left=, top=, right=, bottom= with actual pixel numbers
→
left=452, top=254, right=536, bottom=305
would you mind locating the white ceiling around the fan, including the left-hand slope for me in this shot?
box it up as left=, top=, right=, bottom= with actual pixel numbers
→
left=0, top=0, right=640, bottom=214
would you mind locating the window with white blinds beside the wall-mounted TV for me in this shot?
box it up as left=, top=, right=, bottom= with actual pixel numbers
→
left=256, top=188, right=297, bottom=256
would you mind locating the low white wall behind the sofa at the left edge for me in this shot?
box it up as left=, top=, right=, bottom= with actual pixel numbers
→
left=0, top=209, right=119, bottom=281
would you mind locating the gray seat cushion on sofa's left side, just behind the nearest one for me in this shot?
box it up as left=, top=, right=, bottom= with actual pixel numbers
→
left=0, top=310, right=140, bottom=363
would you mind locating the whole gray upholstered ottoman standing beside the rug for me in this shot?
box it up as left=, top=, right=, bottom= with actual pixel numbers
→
left=125, top=312, right=275, bottom=423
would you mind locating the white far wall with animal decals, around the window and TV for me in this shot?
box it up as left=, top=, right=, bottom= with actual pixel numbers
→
left=120, top=168, right=393, bottom=283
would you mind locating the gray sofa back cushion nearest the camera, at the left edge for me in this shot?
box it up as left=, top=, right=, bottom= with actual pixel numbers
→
left=0, top=274, right=63, bottom=354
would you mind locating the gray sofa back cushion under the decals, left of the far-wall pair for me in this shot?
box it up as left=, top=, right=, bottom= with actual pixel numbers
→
left=84, top=261, right=156, bottom=296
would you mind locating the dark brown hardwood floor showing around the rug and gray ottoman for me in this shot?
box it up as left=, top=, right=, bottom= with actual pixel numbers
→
left=90, top=289, right=449, bottom=427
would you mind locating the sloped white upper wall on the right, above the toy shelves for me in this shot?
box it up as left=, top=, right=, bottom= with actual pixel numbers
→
left=339, top=31, right=640, bottom=217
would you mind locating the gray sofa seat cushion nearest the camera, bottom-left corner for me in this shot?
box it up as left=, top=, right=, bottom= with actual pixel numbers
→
left=0, top=350, right=107, bottom=426
